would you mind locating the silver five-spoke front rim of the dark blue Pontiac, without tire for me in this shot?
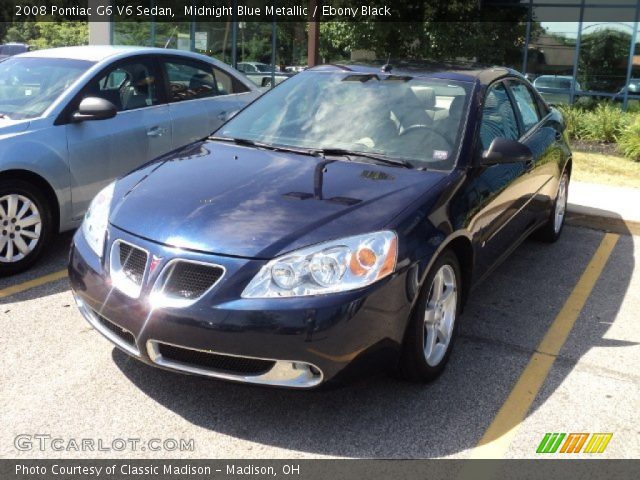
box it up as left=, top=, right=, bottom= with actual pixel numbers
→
left=423, top=264, right=458, bottom=367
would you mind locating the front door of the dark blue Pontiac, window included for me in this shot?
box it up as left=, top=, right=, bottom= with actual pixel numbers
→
left=467, top=81, right=531, bottom=273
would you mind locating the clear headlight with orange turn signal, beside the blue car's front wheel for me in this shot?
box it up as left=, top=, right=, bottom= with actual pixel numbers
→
left=242, top=231, right=398, bottom=298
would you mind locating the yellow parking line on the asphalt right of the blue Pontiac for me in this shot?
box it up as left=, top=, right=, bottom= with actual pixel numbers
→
left=470, top=233, right=619, bottom=458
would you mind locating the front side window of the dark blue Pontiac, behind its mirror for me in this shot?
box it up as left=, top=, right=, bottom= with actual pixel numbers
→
left=480, top=83, right=520, bottom=150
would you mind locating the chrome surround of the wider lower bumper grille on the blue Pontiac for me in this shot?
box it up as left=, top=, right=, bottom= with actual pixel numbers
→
left=147, top=340, right=324, bottom=388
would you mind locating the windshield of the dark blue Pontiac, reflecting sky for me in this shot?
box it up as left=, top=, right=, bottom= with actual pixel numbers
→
left=216, top=71, right=472, bottom=169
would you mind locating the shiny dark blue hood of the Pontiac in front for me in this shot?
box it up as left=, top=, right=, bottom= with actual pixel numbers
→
left=110, top=141, right=445, bottom=258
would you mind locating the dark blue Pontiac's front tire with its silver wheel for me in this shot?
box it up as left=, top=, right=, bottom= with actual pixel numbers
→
left=398, top=250, right=462, bottom=383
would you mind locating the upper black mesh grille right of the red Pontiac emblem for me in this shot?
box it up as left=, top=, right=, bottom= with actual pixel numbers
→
left=163, top=261, right=224, bottom=300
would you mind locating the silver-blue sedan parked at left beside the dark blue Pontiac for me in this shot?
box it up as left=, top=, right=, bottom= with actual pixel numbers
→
left=0, top=46, right=259, bottom=275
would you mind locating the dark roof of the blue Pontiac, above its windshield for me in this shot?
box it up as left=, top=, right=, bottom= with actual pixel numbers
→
left=310, top=62, right=524, bottom=85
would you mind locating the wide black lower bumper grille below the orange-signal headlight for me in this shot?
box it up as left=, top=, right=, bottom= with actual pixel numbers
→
left=157, top=343, right=276, bottom=375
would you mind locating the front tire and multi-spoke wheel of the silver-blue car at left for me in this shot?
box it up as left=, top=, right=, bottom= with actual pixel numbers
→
left=0, top=180, right=53, bottom=276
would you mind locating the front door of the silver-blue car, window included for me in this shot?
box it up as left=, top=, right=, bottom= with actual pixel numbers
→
left=65, top=56, right=172, bottom=217
